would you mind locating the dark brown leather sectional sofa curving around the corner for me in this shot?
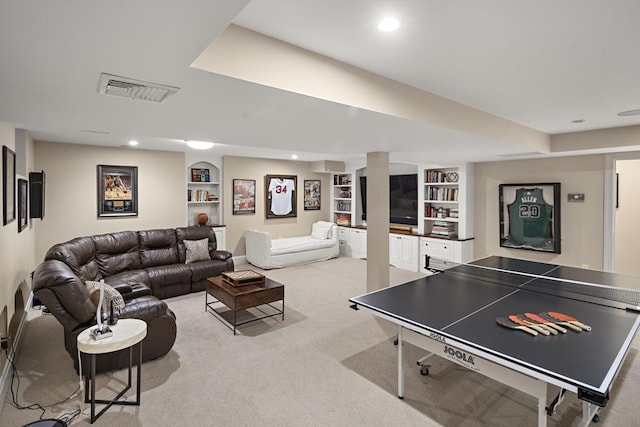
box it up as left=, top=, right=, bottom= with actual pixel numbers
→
left=33, top=227, right=234, bottom=372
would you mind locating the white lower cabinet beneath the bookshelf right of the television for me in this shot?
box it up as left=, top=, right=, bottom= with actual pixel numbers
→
left=420, top=237, right=473, bottom=273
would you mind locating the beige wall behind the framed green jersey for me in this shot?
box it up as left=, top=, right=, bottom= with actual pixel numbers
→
left=474, top=155, right=605, bottom=270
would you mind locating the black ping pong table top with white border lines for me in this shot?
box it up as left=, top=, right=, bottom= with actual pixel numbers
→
left=349, top=257, right=640, bottom=394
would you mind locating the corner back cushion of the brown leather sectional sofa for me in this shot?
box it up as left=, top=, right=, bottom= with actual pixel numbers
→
left=44, top=237, right=102, bottom=280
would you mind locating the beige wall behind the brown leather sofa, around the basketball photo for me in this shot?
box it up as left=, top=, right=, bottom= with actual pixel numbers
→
left=35, top=142, right=187, bottom=262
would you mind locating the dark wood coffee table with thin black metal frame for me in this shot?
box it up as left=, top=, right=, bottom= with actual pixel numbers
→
left=204, top=276, right=284, bottom=335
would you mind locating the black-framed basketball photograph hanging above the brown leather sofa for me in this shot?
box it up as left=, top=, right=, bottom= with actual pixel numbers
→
left=98, top=165, right=138, bottom=217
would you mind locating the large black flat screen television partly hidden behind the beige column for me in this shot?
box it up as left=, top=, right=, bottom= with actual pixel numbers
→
left=360, top=174, right=418, bottom=225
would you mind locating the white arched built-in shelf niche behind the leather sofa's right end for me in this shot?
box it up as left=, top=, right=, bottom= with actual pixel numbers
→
left=187, top=162, right=222, bottom=226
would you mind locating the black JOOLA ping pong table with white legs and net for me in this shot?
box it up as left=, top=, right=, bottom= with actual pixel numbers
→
left=349, top=256, right=640, bottom=426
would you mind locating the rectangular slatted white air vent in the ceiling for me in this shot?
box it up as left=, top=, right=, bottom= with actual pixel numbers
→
left=98, top=73, right=180, bottom=103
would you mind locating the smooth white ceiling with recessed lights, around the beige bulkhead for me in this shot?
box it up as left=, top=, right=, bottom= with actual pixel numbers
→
left=0, top=0, right=640, bottom=163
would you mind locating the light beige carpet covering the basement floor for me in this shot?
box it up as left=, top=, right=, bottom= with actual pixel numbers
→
left=0, top=257, right=640, bottom=427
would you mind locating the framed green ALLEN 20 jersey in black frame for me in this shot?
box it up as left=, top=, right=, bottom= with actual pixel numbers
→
left=500, top=182, right=561, bottom=254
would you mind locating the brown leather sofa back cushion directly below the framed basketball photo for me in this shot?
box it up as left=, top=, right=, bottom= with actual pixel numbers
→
left=93, top=231, right=140, bottom=277
